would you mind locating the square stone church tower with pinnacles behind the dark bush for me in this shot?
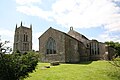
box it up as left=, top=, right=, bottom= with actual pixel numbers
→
left=13, top=22, right=32, bottom=53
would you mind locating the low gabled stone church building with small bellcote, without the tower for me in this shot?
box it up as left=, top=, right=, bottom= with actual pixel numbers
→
left=38, top=27, right=114, bottom=63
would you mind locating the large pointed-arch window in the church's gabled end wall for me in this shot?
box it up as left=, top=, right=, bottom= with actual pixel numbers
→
left=46, top=37, right=56, bottom=54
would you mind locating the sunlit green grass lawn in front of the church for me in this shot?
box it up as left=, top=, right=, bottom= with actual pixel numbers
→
left=25, top=61, right=120, bottom=80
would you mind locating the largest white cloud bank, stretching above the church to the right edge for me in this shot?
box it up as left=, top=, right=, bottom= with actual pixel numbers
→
left=16, top=0, right=120, bottom=31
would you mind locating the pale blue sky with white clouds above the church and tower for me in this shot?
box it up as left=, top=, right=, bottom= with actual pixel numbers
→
left=0, top=0, right=120, bottom=50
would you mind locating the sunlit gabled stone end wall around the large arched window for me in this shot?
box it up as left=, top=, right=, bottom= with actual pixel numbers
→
left=39, top=28, right=65, bottom=62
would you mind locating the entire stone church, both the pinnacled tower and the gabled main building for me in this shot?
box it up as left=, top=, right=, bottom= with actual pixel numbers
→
left=13, top=22, right=115, bottom=63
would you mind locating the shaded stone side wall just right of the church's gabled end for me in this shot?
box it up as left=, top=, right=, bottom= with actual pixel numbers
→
left=65, top=36, right=80, bottom=63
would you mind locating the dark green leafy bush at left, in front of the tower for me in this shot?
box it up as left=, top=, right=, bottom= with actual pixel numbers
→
left=0, top=39, right=38, bottom=80
